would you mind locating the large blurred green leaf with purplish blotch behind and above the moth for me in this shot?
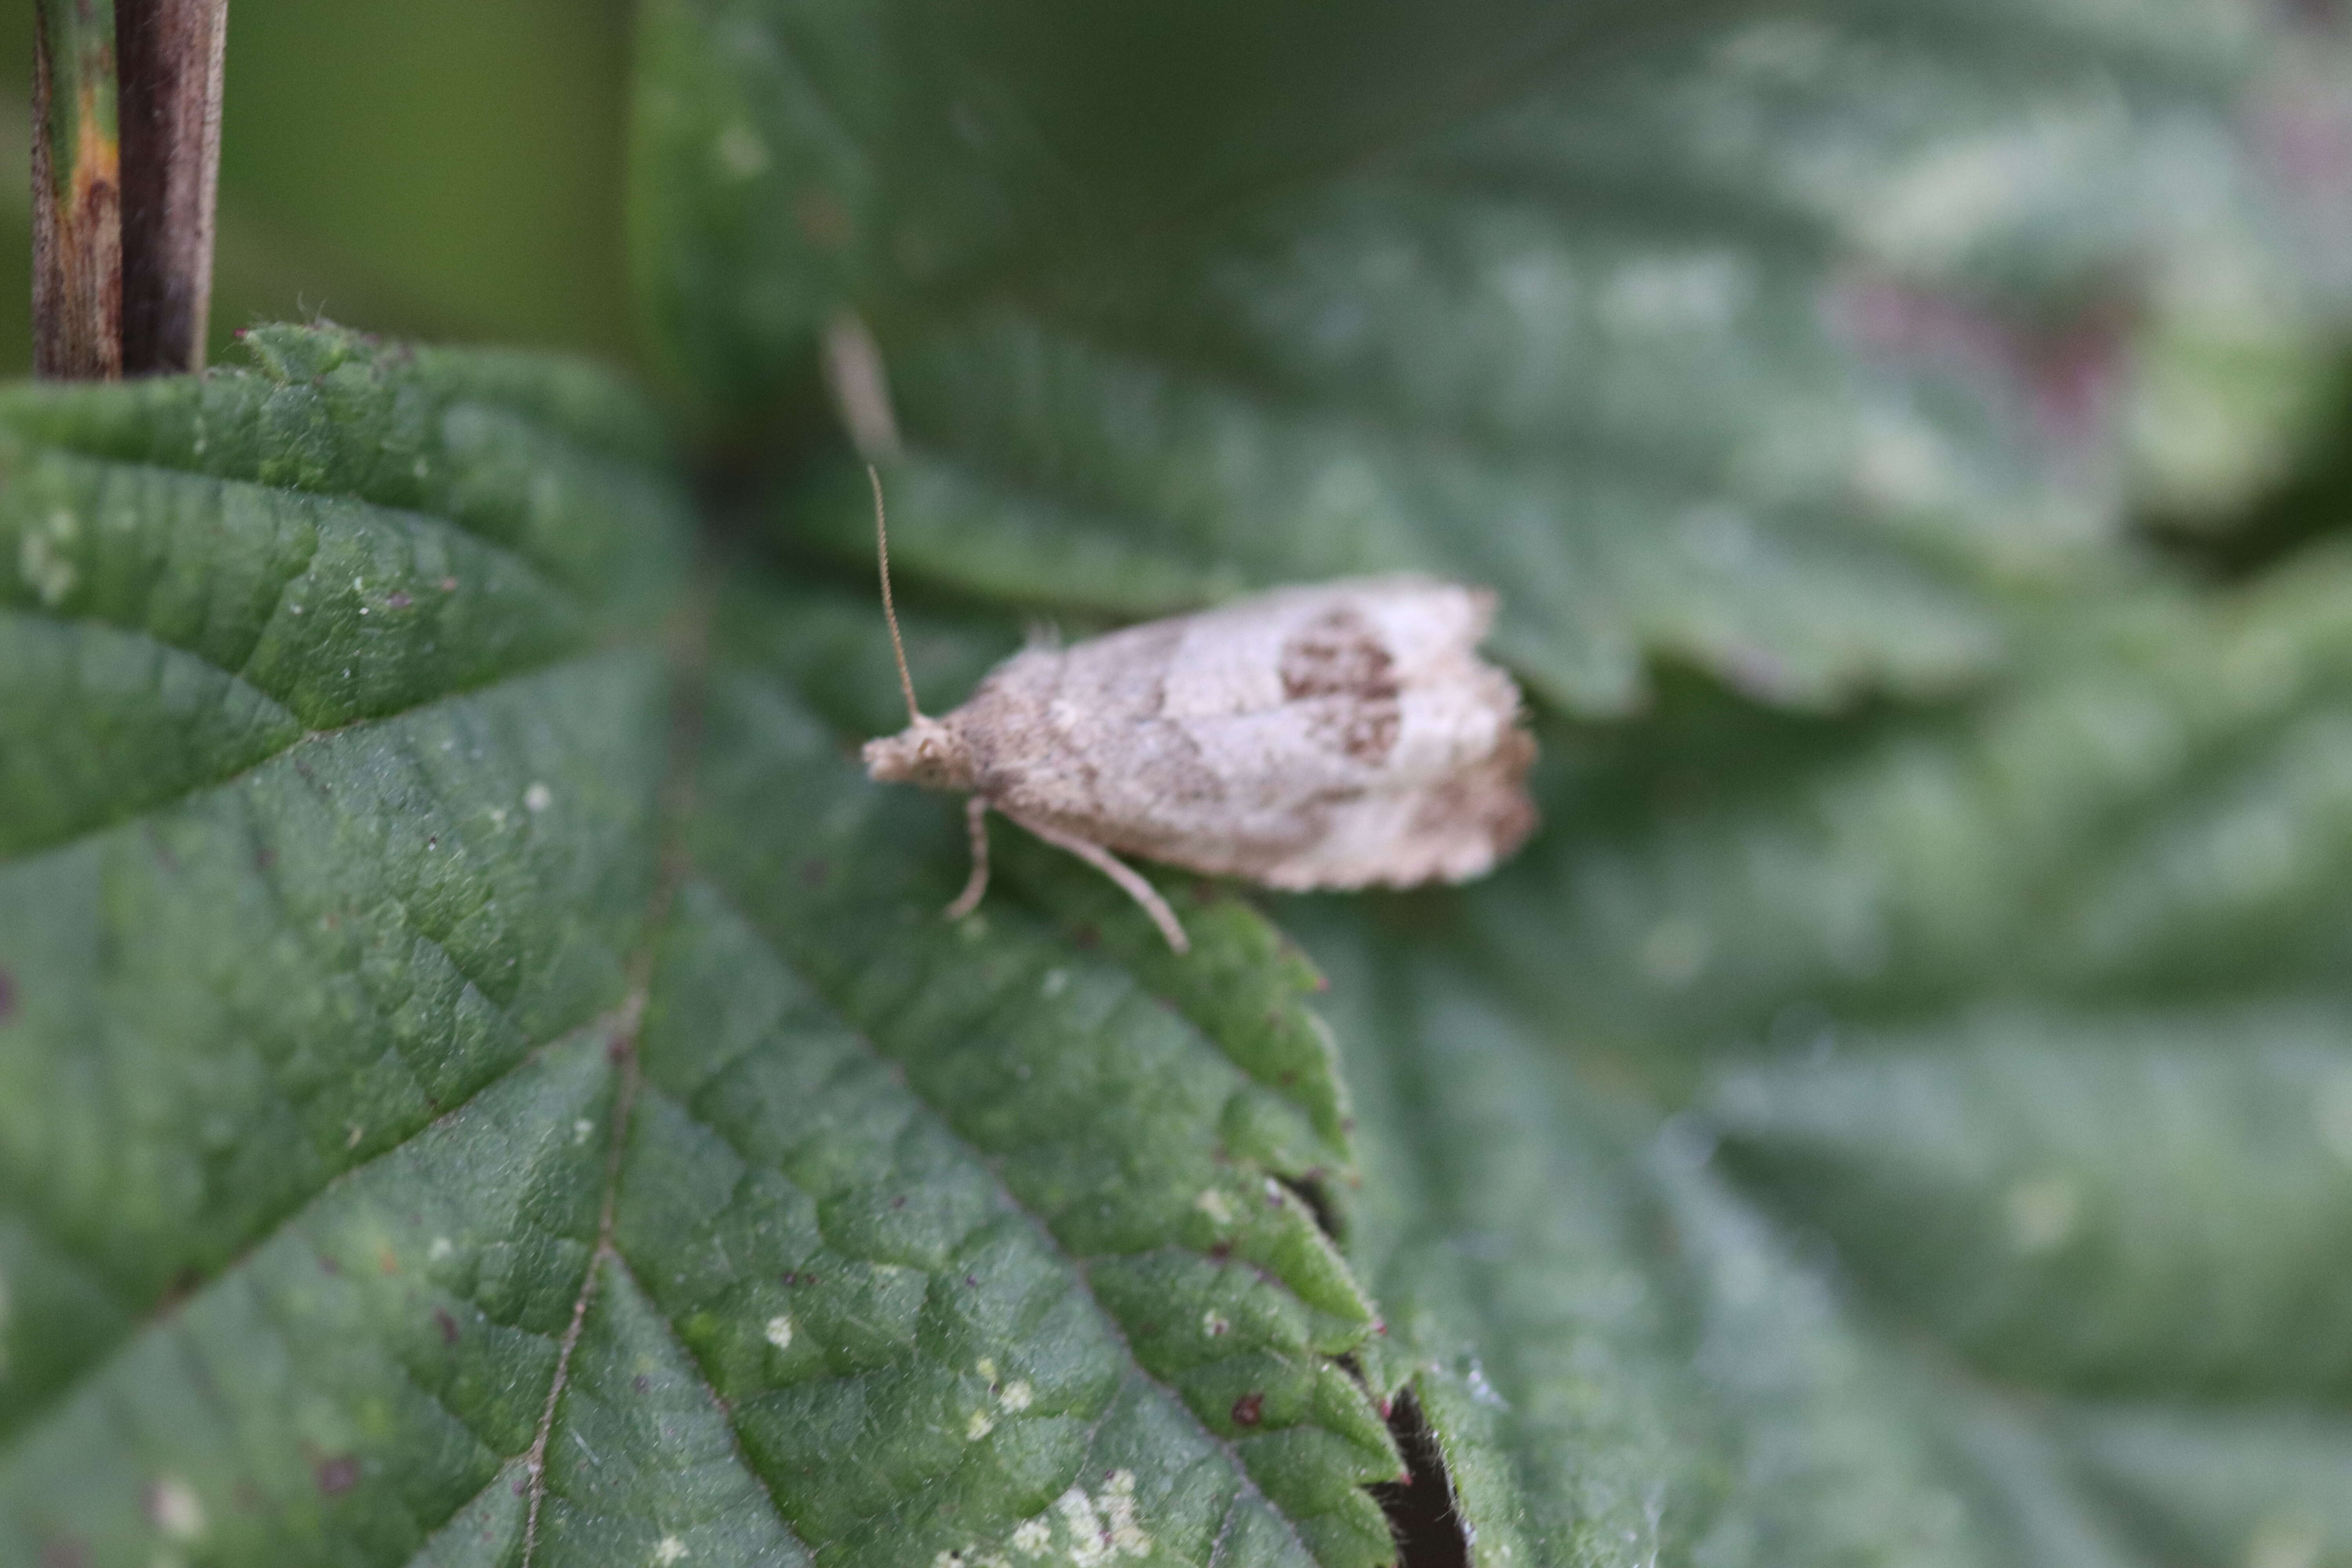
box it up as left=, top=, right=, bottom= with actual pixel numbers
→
left=633, top=0, right=2312, bottom=712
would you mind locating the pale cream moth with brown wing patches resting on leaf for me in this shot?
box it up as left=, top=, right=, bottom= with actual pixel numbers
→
left=863, top=468, right=1536, bottom=952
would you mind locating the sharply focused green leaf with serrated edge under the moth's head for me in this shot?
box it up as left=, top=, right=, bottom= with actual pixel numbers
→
left=0, top=327, right=1399, bottom=1568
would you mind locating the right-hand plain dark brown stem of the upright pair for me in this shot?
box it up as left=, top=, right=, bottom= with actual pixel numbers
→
left=115, top=0, right=228, bottom=376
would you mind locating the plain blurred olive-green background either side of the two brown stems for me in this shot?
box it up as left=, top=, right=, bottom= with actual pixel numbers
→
left=0, top=0, right=633, bottom=376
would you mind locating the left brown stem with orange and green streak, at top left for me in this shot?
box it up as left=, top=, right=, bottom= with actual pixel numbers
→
left=33, top=0, right=122, bottom=381
